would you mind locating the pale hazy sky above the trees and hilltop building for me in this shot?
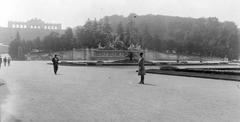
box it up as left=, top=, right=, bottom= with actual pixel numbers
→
left=0, top=0, right=240, bottom=28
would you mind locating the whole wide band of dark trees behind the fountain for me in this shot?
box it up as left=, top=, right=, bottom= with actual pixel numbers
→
left=9, top=14, right=240, bottom=59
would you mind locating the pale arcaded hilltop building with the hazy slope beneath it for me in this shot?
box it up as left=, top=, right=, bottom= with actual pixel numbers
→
left=0, top=18, right=64, bottom=45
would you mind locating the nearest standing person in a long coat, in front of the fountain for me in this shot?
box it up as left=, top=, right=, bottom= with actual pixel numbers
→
left=138, top=52, right=146, bottom=84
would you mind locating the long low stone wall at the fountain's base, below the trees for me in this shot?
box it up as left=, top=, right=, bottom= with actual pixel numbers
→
left=28, top=49, right=222, bottom=61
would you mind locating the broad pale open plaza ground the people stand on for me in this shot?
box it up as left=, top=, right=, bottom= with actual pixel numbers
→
left=0, top=61, right=240, bottom=122
